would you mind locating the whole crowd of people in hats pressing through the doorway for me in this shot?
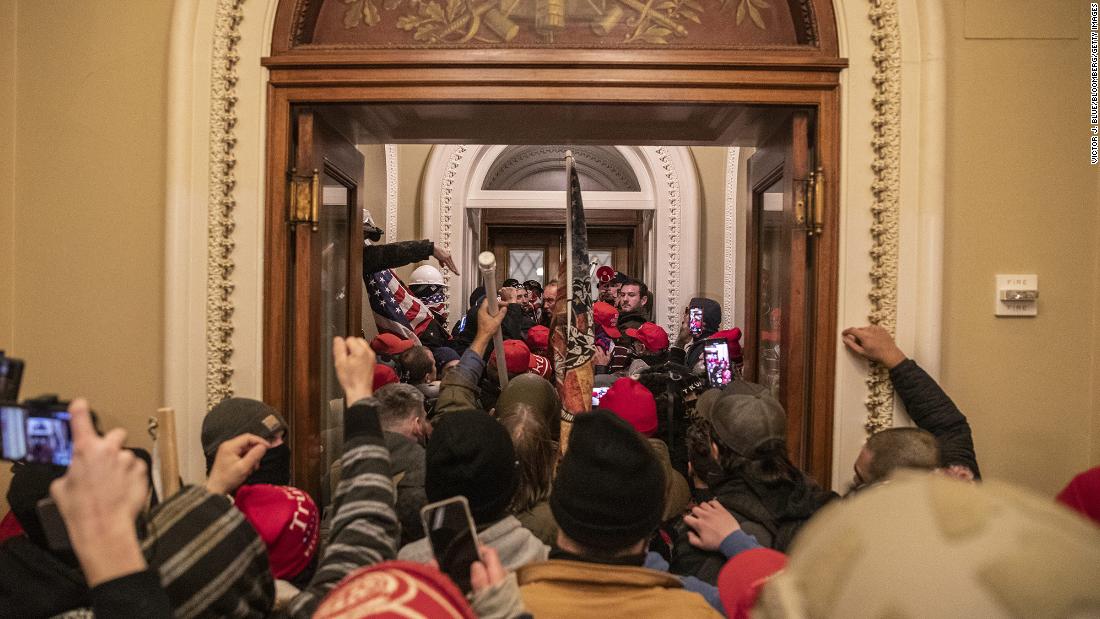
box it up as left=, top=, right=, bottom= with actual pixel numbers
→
left=0, top=236, right=1100, bottom=619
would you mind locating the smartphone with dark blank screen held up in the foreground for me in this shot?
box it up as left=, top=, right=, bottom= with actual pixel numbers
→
left=420, top=496, right=481, bottom=593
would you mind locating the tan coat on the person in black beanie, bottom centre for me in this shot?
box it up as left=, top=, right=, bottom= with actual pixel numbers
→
left=518, top=559, right=722, bottom=619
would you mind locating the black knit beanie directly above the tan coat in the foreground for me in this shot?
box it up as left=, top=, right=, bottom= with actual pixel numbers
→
left=550, top=409, right=664, bottom=551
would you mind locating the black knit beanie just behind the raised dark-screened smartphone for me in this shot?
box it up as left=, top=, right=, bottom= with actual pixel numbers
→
left=424, top=410, right=519, bottom=524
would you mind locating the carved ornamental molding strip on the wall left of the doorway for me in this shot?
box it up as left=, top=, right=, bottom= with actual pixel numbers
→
left=206, top=0, right=244, bottom=410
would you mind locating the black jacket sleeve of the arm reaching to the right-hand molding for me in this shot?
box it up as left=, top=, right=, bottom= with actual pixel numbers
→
left=890, top=358, right=981, bottom=479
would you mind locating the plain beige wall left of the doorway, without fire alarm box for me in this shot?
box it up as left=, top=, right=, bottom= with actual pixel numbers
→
left=0, top=0, right=172, bottom=507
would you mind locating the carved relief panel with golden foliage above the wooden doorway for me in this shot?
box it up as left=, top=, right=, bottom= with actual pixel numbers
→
left=294, top=0, right=816, bottom=49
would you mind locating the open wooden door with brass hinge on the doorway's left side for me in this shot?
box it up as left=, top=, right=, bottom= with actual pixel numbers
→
left=284, top=109, right=363, bottom=505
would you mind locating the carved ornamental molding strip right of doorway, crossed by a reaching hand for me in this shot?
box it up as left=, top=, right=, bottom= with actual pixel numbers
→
left=866, top=0, right=901, bottom=433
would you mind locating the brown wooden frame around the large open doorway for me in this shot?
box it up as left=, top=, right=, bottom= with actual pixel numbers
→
left=263, top=65, right=847, bottom=485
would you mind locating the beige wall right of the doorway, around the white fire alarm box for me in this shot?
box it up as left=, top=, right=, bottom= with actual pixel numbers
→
left=943, top=0, right=1100, bottom=495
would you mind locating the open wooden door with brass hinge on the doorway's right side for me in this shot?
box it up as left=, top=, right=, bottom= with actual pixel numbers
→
left=745, top=111, right=814, bottom=469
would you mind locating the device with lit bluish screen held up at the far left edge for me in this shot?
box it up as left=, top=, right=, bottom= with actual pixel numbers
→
left=0, top=405, right=73, bottom=466
